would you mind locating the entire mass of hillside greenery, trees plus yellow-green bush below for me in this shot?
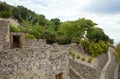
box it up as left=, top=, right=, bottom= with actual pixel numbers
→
left=0, top=2, right=113, bottom=58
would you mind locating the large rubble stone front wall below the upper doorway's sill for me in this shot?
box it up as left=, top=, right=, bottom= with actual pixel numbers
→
left=0, top=47, right=69, bottom=79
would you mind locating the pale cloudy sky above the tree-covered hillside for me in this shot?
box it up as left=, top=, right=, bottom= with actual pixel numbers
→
left=0, top=0, right=120, bottom=43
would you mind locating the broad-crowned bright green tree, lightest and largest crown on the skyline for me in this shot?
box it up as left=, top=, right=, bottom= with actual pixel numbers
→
left=59, top=18, right=96, bottom=40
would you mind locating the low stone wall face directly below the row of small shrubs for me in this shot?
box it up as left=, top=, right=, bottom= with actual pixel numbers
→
left=70, top=59, right=97, bottom=79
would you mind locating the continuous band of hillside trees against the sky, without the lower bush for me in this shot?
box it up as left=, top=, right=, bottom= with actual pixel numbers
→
left=0, top=2, right=113, bottom=44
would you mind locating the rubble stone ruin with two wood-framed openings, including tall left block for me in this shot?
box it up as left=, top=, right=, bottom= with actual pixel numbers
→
left=0, top=19, right=69, bottom=79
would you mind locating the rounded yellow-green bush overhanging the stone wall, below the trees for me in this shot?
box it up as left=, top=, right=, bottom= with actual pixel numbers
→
left=81, top=39, right=109, bottom=57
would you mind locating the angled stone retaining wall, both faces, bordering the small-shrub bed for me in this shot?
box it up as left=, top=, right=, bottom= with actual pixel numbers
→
left=70, top=53, right=108, bottom=79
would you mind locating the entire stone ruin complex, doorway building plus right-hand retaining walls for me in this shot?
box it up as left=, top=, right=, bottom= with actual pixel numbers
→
left=0, top=19, right=118, bottom=79
